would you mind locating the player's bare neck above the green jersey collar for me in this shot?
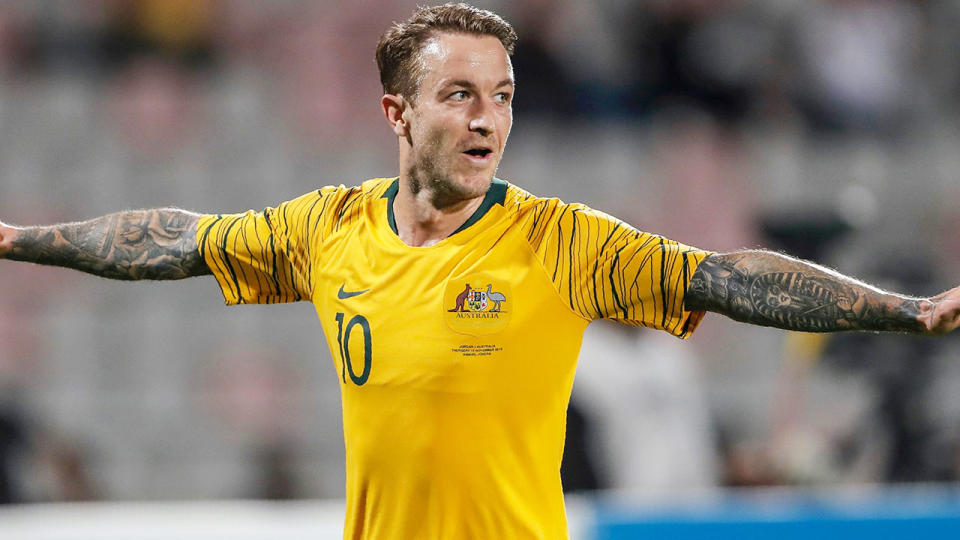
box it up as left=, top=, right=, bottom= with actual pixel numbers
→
left=393, top=177, right=484, bottom=247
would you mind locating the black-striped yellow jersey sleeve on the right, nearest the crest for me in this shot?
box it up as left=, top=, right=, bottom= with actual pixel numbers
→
left=516, top=199, right=710, bottom=338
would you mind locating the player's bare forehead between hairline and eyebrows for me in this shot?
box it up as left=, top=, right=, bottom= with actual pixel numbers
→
left=420, top=33, right=513, bottom=86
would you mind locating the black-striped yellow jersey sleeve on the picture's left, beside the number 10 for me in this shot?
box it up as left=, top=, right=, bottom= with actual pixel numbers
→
left=197, top=188, right=342, bottom=305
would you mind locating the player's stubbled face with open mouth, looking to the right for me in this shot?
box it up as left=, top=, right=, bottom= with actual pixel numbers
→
left=401, top=34, right=514, bottom=207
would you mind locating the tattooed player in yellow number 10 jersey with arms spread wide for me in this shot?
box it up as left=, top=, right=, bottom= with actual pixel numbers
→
left=0, top=4, right=960, bottom=539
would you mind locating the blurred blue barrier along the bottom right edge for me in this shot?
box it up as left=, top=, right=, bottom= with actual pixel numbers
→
left=593, top=488, right=960, bottom=540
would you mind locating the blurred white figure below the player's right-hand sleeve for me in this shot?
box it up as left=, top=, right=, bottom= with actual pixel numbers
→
left=573, top=321, right=715, bottom=495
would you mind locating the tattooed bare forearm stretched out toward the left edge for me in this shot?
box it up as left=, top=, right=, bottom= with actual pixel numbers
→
left=7, top=208, right=210, bottom=280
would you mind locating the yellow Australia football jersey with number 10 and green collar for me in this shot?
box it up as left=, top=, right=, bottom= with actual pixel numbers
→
left=197, top=178, right=708, bottom=540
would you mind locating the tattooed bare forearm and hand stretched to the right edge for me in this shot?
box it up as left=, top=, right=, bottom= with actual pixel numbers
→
left=684, top=251, right=960, bottom=334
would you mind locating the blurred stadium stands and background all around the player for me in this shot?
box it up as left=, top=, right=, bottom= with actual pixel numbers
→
left=0, top=0, right=960, bottom=539
